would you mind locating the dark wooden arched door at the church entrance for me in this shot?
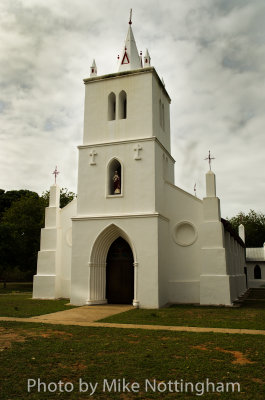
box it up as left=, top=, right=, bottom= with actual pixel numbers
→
left=106, top=237, right=134, bottom=304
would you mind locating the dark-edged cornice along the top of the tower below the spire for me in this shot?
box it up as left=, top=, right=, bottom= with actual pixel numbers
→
left=83, top=67, right=171, bottom=103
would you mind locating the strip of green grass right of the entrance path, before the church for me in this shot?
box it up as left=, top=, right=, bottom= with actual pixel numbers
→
left=101, top=301, right=265, bottom=329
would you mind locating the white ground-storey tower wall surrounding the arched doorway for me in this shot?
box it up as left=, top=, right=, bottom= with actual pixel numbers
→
left=71, top=216, right=160, bottom=308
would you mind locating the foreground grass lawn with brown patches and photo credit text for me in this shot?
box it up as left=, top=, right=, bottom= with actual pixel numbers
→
left=0, top=322, right=265, bottom=400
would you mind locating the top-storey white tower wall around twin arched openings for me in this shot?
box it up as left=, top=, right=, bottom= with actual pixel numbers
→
left=83, top=68, right=170, bottom=150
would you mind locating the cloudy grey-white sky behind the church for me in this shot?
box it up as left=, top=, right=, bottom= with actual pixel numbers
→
left=0, top=0, right=265, bottom=217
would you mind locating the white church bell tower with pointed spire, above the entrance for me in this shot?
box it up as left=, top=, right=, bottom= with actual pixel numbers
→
left=71, top=12, right=174, bottom=305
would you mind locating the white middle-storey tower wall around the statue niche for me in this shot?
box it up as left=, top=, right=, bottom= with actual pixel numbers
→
left=77, top=139, right=155, bottom=215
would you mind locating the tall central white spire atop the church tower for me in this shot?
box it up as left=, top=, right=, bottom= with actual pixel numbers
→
left=118, top=11, right=142, bottom=72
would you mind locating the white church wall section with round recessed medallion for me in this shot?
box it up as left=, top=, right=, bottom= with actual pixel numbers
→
left=163, top=182, right=203, bottom=303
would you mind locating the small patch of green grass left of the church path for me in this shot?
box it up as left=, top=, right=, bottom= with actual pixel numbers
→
left=0, top=293, right=76, bottom=318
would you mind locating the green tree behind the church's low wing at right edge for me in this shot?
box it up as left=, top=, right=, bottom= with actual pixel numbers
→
left=228, top=210, right=265, bottom=247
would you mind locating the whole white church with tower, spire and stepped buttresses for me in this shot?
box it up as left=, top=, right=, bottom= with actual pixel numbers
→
left=33, top=16, right=246, bottom=308
